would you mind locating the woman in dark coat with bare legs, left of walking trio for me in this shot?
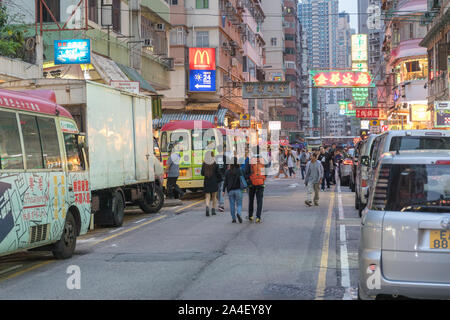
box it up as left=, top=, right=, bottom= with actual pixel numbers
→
left=201, top=151, right=222, bottom=217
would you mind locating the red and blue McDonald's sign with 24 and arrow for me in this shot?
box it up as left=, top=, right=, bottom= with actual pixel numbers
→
left=189, top=48, right=216, bottom=92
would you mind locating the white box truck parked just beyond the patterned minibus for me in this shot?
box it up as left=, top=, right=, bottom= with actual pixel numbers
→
left=1, top=79, right=164, bottom=227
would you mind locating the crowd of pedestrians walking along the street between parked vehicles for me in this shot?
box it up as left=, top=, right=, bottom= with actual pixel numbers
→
left=167, top=144, right=352, bottom=223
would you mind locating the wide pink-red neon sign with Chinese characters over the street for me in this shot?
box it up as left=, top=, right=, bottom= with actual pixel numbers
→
left=311, top=71, right=374, bottom=88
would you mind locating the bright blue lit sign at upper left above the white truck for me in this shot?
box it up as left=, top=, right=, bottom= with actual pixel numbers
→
left=53, top=39, right=91, bottom=64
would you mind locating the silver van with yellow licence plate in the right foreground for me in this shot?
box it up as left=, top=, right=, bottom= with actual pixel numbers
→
left=358, top=150, right=450, bottom=299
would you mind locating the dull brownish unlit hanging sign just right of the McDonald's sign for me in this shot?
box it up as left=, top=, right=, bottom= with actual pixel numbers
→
left=242, top=81, right=291, bottom=99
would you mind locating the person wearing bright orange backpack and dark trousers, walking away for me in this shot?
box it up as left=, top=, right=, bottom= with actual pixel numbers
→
left=245, top=156, right=266, bottom=223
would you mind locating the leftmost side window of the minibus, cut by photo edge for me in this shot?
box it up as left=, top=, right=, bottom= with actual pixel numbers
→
left=0, top=111, right=24, bottom=170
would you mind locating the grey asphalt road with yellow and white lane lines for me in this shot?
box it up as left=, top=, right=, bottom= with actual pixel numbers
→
left=0, top=174, right=360, bottom=300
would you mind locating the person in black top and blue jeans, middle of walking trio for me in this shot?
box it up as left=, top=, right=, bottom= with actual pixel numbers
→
left=220, top=158, right=245, bottom=223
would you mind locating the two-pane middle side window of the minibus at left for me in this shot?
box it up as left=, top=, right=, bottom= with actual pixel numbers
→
left=20, top=114, right=62, bottom=169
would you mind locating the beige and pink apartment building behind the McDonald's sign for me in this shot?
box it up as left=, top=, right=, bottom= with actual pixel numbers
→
left=159, top=0, right=268, bottom=127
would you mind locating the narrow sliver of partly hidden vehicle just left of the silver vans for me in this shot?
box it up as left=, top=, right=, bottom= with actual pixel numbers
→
left=355, top=134, right=378, bottom=217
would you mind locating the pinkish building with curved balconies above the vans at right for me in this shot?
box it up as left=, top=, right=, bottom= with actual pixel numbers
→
left=379, top=0, right=432, bottom=130
